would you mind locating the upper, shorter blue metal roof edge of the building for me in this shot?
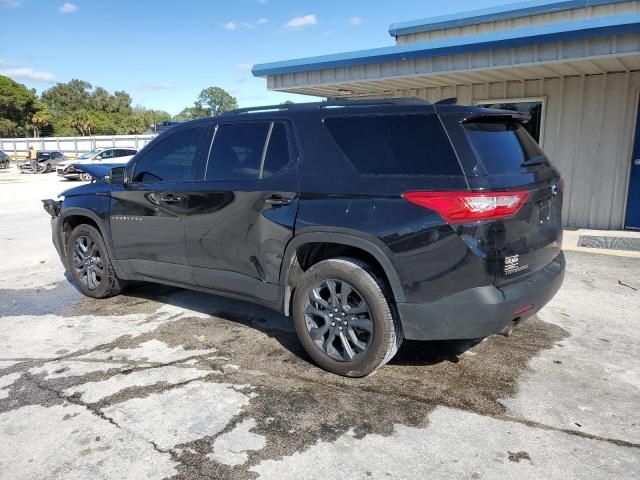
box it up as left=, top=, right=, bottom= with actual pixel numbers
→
left=389, top=0, right=629, bottom=37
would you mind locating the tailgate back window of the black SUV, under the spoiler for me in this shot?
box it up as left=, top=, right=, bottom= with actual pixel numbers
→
left=464, top=122, right=546, bottom=175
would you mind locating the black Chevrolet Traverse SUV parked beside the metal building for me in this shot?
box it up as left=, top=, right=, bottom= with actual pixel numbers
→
left=45, top=99, right=565, bottom=377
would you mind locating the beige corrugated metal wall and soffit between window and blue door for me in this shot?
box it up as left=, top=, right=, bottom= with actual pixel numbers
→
left=394, top=72, right=640, bottom=229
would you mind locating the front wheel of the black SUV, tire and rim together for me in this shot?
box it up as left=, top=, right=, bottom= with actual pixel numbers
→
left=66, top=224, right=123, bottom=298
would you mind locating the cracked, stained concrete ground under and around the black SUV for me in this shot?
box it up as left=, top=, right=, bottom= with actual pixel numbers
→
left=0, top=172, right=640, bottom=480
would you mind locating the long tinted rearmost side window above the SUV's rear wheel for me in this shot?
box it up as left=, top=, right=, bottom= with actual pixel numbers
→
left=324, top=115, right=462, bottom=175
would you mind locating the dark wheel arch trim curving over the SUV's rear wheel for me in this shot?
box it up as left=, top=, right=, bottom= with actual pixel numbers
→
left=280, top=232, right=405, bottom=316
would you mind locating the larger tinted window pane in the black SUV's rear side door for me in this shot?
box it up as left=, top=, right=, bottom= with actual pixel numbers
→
left=206, top=123, right=270, bottom=180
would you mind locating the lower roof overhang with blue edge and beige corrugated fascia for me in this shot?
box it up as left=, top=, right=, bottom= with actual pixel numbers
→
left=254, top=14, right=640, bottom=98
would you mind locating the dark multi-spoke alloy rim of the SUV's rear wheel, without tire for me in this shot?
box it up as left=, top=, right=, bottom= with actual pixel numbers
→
left=304, top=279, right=373, bottom=362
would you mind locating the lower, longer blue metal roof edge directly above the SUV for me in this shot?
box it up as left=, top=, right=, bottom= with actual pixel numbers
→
left=251, top=13, right=640, bottom=77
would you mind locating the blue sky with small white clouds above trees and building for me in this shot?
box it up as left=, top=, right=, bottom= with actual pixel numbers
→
left=0, top=0, right=520, bottom=114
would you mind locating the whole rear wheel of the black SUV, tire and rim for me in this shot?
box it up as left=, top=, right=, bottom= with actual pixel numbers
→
left=293, top=258, right=402, bottom=377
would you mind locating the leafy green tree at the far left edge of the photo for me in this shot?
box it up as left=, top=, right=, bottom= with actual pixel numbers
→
left=0, top=75, right=37, bottom=137
